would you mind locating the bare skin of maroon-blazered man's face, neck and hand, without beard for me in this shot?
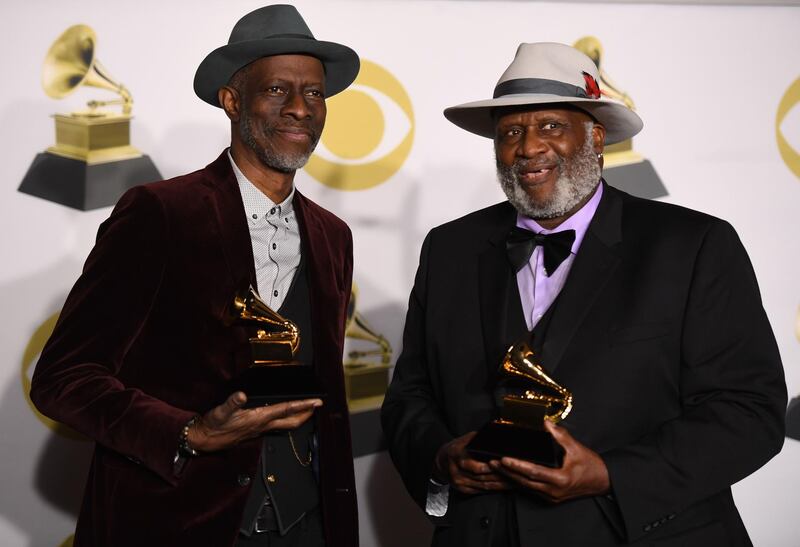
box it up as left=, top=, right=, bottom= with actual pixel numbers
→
left=188, top=55, right=327, bottom=452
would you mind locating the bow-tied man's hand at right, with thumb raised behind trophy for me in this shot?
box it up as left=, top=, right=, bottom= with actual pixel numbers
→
left=489, top=420, right=611, bottom=503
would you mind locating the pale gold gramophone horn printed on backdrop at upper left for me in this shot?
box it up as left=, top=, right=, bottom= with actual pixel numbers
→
left=42, top=25, right=133, bottom=114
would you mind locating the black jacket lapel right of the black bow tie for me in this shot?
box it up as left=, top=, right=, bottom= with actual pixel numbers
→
left=541, top=182, right=622, bottom=372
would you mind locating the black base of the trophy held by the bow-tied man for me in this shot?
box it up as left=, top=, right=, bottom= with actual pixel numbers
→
left=467, top=422, right=564, bottom=467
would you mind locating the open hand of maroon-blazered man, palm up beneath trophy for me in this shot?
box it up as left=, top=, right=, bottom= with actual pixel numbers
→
left=188, top=391, right=322, bottom=452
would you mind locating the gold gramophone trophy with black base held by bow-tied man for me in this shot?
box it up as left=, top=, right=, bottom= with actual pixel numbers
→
left=467, top=342, right=572, bottom=467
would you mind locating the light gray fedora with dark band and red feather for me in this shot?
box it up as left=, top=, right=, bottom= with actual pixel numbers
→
left=444, top=42, right=643, bottom=144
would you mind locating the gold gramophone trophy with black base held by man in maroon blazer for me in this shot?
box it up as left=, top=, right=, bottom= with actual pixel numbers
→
left=227, top=287, right=325, bottom=408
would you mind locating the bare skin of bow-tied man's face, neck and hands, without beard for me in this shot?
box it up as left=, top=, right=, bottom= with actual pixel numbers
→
left=434, top=105, right=611, bottom=503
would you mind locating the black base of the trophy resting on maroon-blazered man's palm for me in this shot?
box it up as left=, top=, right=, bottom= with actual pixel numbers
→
left=233, top=363, right=325, bottom=408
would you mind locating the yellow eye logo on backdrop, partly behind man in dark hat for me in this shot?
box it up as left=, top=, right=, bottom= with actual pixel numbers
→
left=305, top=60, right=414, bottom=190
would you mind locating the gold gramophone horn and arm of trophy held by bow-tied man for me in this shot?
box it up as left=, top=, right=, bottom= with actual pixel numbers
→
left=500, top=342, right=572, bottom=423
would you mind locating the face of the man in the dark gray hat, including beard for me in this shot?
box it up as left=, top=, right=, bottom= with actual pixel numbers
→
left=222, top=55, right=327, bottom=173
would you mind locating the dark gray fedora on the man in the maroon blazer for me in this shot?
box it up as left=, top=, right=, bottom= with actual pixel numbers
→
left=194, top=4, right=361, bottom=107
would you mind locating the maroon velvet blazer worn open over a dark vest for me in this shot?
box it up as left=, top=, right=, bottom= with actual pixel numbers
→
left=31, top=152, right=358, bottom=547
